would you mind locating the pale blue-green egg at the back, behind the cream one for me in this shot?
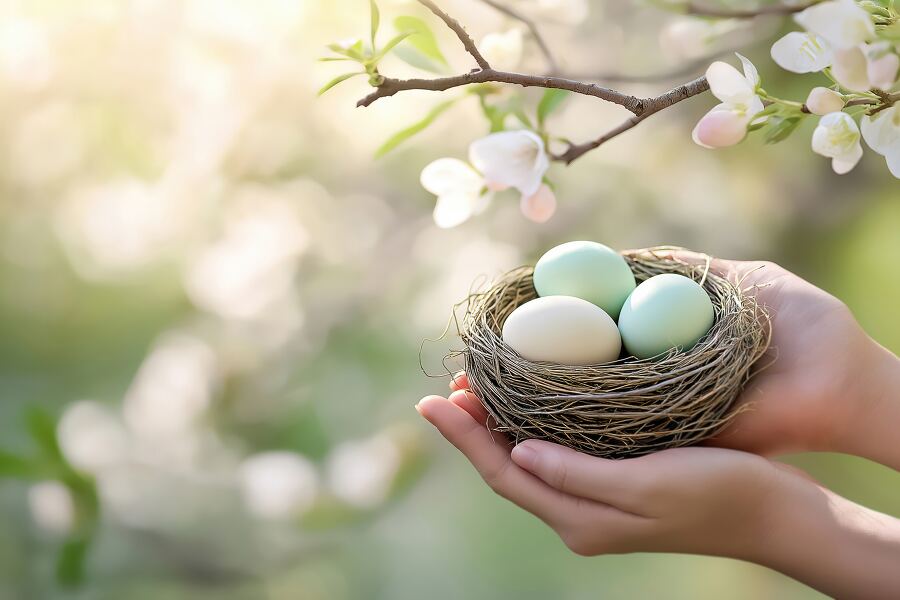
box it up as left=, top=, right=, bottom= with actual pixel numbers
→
left=533, top=242, right=635, bottom=319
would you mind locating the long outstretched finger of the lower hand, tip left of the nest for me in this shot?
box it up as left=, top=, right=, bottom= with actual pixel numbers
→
left=416, top=396, right=577, bottom=526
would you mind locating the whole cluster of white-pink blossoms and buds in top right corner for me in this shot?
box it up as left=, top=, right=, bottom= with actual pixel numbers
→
left=693, top=0, right=900, bottom=178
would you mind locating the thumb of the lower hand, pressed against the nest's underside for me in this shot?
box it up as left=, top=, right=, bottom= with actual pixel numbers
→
left=512, top=440, right=649, bottom=512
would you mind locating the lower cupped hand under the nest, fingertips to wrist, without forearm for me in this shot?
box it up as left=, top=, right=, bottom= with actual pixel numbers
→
left=416, top=390, right=792, bottom=558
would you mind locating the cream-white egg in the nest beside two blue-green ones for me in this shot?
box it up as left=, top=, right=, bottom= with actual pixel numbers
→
left=503, top=296, right=622, bottom=365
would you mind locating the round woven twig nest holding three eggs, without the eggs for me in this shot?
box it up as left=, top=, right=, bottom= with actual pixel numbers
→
left=460, top=248, right=769, bottom=458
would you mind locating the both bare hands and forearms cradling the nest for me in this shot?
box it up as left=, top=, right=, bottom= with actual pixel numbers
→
left=416, top=253, right=900, bottom=598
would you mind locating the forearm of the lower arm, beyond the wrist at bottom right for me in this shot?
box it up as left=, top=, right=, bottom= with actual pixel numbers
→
left=756, top=486, right=900, bottom=599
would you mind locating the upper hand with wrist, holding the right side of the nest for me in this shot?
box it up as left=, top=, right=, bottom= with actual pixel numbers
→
left=660, top=251, right=900, bottom=468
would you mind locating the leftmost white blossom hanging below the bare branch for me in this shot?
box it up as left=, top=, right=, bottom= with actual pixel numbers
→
left=419, top=158, right=489, bottom=229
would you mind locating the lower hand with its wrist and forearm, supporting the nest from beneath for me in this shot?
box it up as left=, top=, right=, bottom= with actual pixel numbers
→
left=416, top=390, right=900, bottom=598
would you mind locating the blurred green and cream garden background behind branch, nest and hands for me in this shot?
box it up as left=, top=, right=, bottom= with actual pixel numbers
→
left=0, top=0, right=900, bottom=600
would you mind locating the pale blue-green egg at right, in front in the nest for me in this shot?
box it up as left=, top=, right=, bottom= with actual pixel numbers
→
left=619, top=273, right=714, bottom=358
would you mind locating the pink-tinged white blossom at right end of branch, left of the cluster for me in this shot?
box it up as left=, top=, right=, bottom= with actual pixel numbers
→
left=692, top=54, right=764, bottom=148
